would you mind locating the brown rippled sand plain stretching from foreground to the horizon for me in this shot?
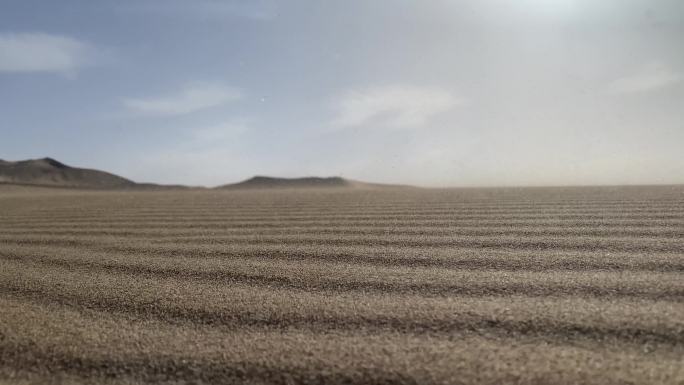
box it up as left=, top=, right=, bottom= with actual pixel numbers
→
left=0, top=186, right=684, bottom=384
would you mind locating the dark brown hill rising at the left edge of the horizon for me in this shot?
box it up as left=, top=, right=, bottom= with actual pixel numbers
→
left=0, top=158, right=139, bottom=189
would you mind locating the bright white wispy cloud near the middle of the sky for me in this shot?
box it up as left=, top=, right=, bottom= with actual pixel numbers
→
left=332, top=85, right=461, bottom=128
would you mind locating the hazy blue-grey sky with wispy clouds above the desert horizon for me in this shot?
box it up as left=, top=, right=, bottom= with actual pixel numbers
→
left=0, top=0, right=684, bottom=186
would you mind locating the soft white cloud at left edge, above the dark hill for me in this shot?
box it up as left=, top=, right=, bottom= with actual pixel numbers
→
left=0, top=33, right=90, bottom=73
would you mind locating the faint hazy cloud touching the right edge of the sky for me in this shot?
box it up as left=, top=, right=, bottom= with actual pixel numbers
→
left=609, top=63, right=684, bottom=94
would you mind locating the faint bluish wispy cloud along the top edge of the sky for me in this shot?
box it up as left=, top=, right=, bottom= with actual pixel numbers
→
left=125, top=0, right=278, bottom=20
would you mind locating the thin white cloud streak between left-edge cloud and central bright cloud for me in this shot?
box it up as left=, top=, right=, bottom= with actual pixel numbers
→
left=124, top=84, right=242, bottom=115
